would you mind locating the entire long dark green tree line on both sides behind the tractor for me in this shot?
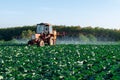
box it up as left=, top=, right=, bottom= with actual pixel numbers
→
left=0, top=25, right=120, bottom=41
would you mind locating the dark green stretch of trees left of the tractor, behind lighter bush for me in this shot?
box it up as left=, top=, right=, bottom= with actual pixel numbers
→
left=0, top=26, right=36, bottom=41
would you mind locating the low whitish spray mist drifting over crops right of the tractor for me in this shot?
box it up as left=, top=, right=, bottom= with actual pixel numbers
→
left=56, top=37, right=119, bottom=45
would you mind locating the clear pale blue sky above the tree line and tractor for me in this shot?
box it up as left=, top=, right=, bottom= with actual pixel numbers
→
left=0, top=0, right=120, bottom=29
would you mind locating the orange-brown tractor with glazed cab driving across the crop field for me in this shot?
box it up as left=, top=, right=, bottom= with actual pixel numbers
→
left=28, top=23, right=57, bottom=46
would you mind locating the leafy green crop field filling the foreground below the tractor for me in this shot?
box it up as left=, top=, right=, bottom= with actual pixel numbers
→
left=0, top=44, right=120, bottom=80
